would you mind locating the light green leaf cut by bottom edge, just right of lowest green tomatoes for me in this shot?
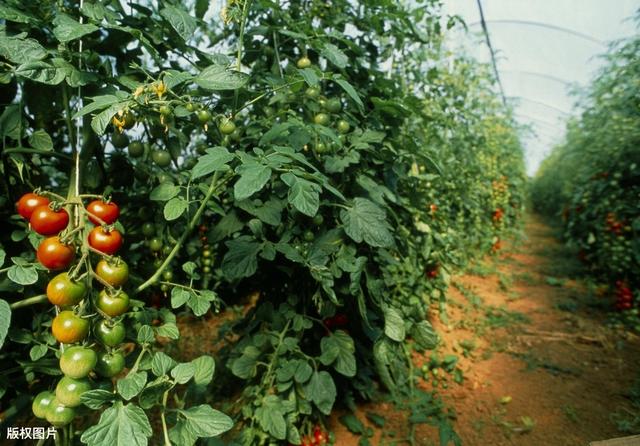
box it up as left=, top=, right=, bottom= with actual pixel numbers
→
left=80, top=401, right=153, bottom=446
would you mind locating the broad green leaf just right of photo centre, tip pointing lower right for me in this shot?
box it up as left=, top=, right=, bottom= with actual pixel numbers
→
left=340, top=198, right=393, bottom=248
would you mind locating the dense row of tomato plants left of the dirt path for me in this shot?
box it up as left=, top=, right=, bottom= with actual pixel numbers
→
left=0, top=0, right=524, bottom=446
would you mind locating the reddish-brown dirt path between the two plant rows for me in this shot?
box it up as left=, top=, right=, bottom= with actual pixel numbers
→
left=332, top=217, right=640, bottom=446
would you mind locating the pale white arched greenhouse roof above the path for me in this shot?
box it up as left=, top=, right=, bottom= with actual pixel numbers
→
left=443, top=0, right=640, bottom=175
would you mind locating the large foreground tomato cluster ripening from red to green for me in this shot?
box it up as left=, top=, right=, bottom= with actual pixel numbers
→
left=17, top=193, right=129, bottom=427
